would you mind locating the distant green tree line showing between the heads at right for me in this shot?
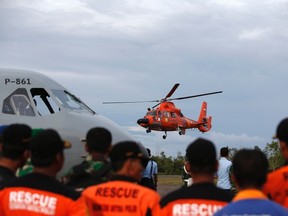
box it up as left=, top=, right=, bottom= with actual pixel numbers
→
left=151, top=141, right=284, bottom=175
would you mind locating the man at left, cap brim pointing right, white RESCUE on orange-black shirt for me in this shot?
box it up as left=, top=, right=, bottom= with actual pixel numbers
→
left=0, top=129, right=86, bottom=216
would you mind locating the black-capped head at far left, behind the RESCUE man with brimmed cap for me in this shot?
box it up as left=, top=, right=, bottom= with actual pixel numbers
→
left=2, top=124, right=32, bottom=165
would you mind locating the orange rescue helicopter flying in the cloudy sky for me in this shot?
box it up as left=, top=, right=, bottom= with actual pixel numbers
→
left=103, top=83, right=222, bottom=139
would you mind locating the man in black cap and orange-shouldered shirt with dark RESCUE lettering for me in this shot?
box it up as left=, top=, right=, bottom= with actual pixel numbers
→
left=82, top=141, right=160, bottom=216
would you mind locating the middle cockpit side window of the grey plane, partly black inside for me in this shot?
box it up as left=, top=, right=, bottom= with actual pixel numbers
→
left=31, top=88, right=60, bottom=116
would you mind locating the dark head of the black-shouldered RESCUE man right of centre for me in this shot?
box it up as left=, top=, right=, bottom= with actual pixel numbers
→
left=185, top=138, right=218, bottom=176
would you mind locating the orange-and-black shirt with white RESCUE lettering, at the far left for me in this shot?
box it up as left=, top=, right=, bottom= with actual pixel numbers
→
left=0, top=174, right=86, bottom=216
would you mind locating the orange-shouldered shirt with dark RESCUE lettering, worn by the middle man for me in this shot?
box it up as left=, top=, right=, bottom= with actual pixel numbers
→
left=82, top=180, right=160, bottom=216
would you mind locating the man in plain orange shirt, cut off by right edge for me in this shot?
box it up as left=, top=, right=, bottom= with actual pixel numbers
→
left=263, top=118, right=288, bottom=208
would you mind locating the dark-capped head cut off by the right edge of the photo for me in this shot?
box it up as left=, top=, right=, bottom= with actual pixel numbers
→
left=275, top=118, right=288, bottom=161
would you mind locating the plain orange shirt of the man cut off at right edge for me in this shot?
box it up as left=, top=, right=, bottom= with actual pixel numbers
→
left=263, top=165, right=288, bottom=208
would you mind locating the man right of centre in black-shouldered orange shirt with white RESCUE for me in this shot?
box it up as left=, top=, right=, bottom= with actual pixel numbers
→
left=158, top=138, right=233, bottom=216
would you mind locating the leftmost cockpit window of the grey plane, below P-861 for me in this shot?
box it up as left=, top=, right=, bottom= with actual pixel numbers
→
left=2, top=88, right=35, bottom=116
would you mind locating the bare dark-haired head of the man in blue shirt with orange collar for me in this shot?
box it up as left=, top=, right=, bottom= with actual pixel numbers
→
left=232, top=149, right=269, bottom=189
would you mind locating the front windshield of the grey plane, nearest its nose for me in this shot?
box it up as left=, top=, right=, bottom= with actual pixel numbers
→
left=52, top=89, right=95, bottom=114
